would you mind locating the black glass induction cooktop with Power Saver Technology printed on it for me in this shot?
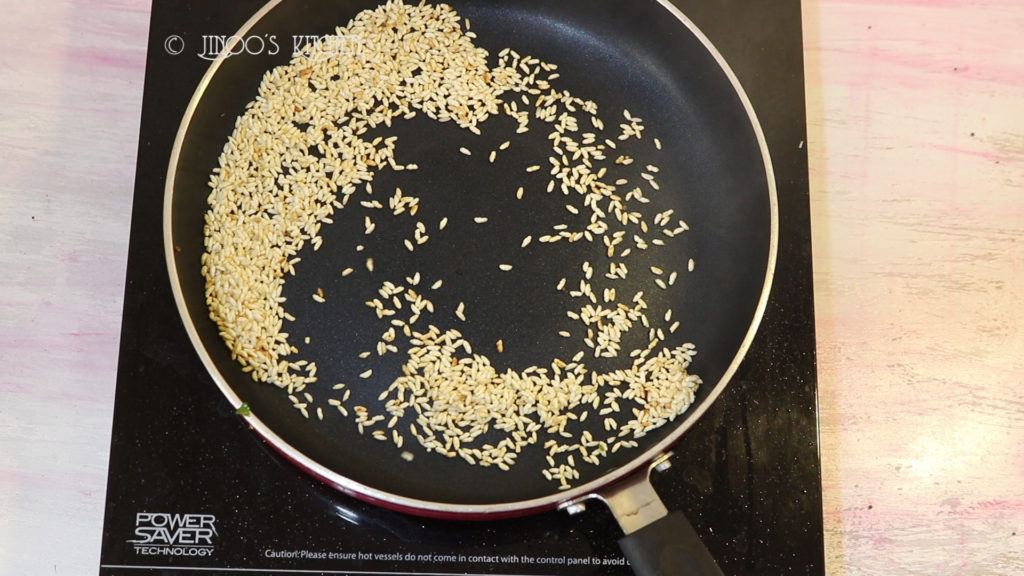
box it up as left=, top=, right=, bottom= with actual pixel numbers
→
left=99, top=0, right=824, bottom=576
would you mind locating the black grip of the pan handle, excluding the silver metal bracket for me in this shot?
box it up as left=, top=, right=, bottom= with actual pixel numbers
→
left=618, top=511, right=723, bottom=576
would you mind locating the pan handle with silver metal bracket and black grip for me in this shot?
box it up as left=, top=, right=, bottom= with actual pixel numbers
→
left=597, top=454, right=723, bottom=576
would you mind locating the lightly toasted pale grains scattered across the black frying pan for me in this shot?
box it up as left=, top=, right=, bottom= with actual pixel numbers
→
left=204, top=2, right=696, bottom=490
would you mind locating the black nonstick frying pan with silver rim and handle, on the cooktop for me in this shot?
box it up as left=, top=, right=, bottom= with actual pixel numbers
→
left=164, top=0, right=778, bottom=575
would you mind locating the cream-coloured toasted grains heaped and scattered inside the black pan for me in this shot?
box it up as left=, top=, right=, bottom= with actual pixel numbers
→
left=202, top=1, right=700, bottom=489
